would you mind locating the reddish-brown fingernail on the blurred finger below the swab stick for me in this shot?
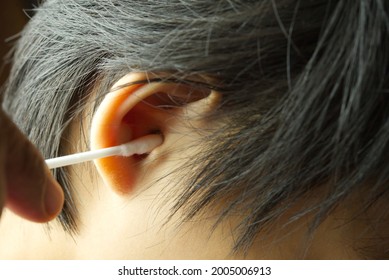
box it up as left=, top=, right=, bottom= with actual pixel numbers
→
left=45, top=176, right=64, bottom=218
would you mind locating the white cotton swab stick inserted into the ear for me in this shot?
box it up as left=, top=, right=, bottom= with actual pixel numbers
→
left=46, top=134, right=163, bottom=169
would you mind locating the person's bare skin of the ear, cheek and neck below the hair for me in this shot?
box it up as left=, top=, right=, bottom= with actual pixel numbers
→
left=0, top=74, right=370, bottom=259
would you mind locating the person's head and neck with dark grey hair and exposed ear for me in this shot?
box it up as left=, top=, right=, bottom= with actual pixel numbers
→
left=3, top=0, right=389, bottom=259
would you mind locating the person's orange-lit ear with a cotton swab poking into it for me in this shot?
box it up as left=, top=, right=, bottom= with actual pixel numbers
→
left=90, top=73, right=218, bottom=194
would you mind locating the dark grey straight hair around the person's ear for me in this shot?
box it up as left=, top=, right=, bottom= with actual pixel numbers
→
left=4, top=0, right=389, bottom=258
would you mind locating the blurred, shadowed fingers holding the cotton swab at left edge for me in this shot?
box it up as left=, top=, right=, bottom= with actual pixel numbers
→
left=0, top=108, right=64, bottom=222
